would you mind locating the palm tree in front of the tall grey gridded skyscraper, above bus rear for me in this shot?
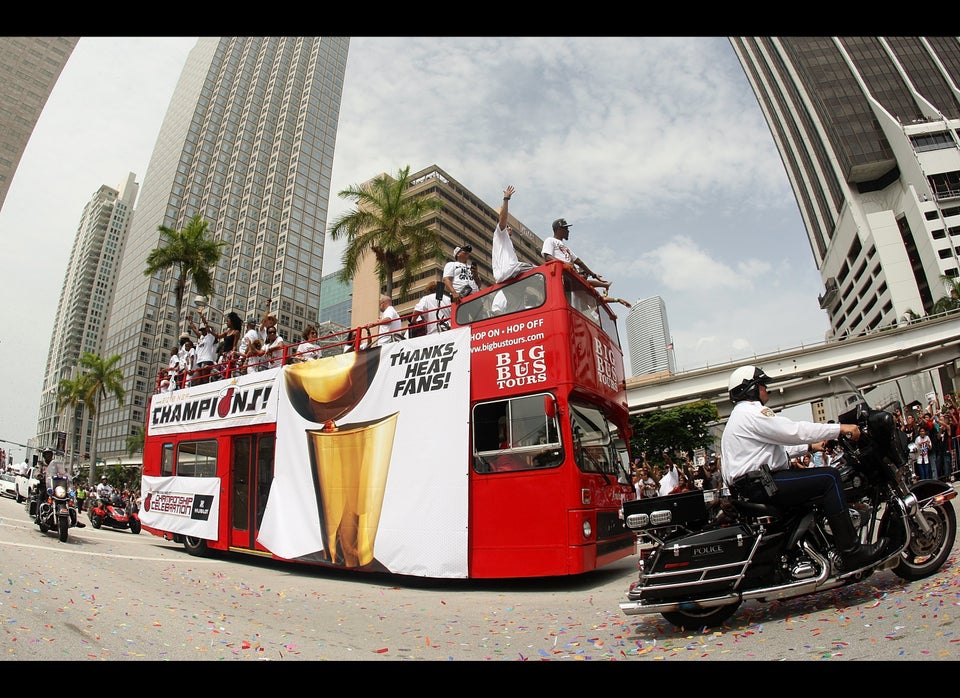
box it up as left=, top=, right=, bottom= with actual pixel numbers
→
left=143, top=215, right=226, bottom=334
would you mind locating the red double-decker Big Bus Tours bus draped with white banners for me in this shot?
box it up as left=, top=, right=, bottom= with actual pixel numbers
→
left=140, top=262, right=635, bottom=578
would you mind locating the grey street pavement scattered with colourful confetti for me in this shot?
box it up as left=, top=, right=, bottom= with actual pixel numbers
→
left=0, top=490, right=960, bottom=664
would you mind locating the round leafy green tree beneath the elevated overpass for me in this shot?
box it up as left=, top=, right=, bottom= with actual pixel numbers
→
left=630, top=400, right=720, bottom=462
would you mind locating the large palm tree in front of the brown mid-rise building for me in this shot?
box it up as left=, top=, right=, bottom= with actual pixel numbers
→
left=329, top=165, right=443, bottom=296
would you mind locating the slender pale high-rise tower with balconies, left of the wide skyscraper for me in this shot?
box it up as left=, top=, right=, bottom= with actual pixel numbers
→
left=37, top=172, right=140, bottom=465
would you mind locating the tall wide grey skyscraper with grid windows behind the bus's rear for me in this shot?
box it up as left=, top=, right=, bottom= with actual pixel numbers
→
left=97, top=36, right=349, bottom=456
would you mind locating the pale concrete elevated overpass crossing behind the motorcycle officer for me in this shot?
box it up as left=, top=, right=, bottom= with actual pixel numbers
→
left=626, top=313, right=960, bottom=420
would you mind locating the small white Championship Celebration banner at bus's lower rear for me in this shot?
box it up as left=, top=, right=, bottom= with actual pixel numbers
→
left=140, top=475, right=220, bottom=540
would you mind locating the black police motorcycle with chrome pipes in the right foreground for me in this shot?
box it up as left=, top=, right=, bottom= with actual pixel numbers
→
left=620, top=378, right=957, bottom=630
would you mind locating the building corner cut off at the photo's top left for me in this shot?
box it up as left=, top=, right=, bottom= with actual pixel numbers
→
left=0, top=36, right=80, bottom=208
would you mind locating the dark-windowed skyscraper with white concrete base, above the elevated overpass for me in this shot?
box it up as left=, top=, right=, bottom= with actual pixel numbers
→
left=730, top=36, right=960, bottom=338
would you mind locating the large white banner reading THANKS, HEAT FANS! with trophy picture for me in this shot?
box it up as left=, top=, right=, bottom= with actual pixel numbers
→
left=257, top=328, right=470, bottom=578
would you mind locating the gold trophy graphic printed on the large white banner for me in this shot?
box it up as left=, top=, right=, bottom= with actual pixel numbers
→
left=284, top=347, right=397, bottom=567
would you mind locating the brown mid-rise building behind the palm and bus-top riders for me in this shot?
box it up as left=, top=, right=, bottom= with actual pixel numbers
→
left=351, top=165, right=543, bottom=325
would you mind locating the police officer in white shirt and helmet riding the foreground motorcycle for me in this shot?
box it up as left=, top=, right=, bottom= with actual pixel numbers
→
left=720, top=366, right=888, bottom=571
